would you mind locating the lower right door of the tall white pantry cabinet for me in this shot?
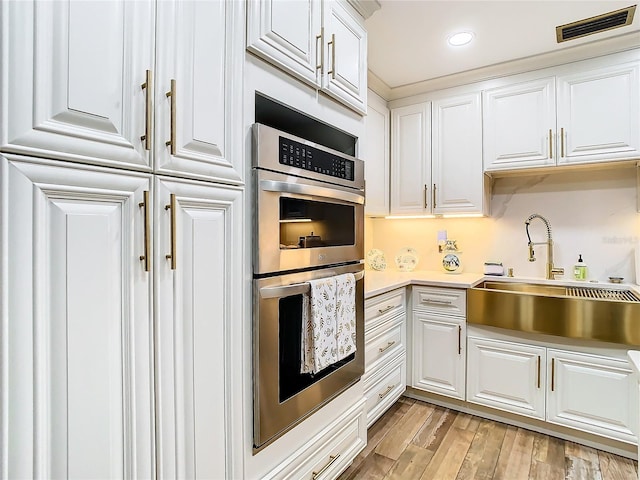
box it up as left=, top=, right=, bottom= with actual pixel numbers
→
left=154, top=179, right=242, bottom=478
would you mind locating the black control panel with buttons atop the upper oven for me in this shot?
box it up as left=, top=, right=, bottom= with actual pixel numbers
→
left=279, top=137, right=355, bottom=180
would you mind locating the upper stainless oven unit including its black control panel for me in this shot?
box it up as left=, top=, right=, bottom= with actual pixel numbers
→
left=253, top=124, right=364, bottom=275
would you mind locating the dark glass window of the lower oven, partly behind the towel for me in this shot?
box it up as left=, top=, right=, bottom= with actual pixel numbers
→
left=278, top=295, right=355, bottom=403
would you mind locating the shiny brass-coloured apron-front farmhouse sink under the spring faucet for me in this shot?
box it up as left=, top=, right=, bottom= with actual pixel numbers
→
left=467, top=281, right=640, bottom=347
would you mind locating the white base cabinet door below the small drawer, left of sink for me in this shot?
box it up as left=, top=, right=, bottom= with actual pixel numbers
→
left=413, top=312, right=466, bottom=399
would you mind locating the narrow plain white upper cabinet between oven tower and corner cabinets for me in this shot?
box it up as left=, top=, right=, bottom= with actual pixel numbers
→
left=362, top=92, right=390, bottom=216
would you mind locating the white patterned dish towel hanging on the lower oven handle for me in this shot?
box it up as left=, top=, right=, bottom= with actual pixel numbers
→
left=300, top=273, right=356, bottom=373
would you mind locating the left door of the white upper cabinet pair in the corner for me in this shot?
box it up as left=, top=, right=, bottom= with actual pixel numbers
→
left=390, top=102, right=431, bottom=215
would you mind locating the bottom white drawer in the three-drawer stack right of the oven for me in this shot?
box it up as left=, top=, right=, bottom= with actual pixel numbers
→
left=364, top=354, right=407, bottom=428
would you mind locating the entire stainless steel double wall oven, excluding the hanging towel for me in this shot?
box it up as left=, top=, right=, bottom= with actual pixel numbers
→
left=253, top=124, right=364, bottom=451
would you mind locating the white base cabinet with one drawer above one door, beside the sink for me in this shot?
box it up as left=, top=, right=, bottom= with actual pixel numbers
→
left=411, top=286, right=466, bottom=399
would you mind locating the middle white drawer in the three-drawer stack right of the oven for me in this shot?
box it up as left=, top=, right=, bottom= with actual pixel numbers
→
left=364, top=316, right=407, bottom=376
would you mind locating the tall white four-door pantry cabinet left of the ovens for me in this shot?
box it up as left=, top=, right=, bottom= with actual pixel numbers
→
left=0, top=0, right=244, bottom=479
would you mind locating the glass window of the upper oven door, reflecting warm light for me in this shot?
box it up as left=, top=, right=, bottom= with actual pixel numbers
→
left=280, top=196, right=356, bottom=249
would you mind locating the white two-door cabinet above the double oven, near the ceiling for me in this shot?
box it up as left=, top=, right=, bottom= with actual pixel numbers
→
left=247, top=0, right=367, bottom=113
